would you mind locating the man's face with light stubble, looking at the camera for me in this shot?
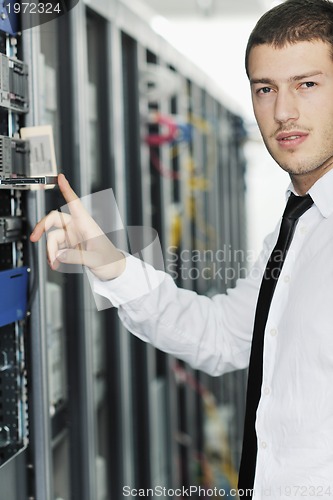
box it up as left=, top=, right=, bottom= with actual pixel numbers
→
left=249, top=40, right=333, bottom=191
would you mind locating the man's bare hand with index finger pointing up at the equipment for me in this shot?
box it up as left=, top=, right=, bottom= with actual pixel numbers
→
left=30, top=174, right=126, bottom=281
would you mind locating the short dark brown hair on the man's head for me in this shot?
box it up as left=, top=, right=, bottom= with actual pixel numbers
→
left=245, top=0, right=333, bottom=76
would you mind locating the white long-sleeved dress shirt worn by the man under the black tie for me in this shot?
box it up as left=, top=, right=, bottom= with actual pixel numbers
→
left=94, top=170, right=333, bottom=500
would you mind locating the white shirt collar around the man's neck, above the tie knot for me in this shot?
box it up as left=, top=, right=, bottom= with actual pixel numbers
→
left=286, top=169, right=333, bottom=218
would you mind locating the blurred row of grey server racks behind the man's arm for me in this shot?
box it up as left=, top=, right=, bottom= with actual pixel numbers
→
left=0, top=0, right=246, bottom=500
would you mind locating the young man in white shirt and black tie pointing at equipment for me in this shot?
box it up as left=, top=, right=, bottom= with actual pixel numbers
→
left=31, top=0, right=333, bottom=499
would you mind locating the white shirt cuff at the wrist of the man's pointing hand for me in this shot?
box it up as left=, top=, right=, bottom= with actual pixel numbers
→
left=88, top=255, right=165, bottom=307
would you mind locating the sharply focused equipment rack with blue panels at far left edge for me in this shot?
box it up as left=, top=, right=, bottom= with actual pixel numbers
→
left=0, top=5, right=36, bottom=499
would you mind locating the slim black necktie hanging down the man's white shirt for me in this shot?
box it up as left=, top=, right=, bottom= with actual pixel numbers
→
left=238, top=194, right=313, bottom=498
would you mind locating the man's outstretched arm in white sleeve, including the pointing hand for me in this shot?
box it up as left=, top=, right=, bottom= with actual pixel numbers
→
left=30, top=175, right=268, bottom=375
